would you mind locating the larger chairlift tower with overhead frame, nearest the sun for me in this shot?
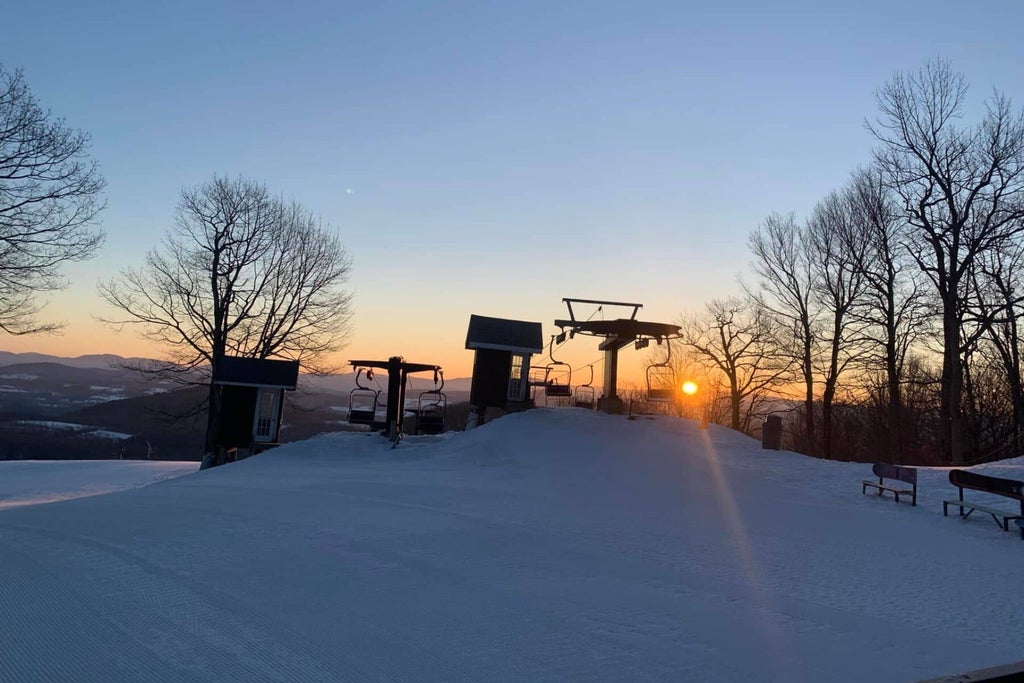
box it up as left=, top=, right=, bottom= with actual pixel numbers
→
left=555, top=298, right=680, bottom=415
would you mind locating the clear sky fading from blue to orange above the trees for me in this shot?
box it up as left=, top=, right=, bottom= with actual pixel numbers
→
left=0, top=0, right=1024, bottom=379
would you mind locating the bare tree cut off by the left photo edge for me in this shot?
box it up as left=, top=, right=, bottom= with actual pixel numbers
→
left=0, top=65, right=104, bottom=335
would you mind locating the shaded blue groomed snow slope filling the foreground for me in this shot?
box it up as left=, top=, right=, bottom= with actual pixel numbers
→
left=0, top=410, right=1024, bottom=682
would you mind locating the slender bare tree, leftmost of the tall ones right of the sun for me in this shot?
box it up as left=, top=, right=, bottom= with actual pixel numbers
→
left=748, top=214, right=818, bottom=455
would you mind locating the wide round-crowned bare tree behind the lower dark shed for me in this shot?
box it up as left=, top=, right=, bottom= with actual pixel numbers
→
left=99, top=178, right=351, bottom=453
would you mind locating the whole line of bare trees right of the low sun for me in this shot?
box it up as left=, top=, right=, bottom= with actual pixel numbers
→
left=679, top=60, right=1024, bottom=465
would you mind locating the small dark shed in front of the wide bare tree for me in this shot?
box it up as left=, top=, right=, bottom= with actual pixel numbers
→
left=213, top=355, right=299, bottom=453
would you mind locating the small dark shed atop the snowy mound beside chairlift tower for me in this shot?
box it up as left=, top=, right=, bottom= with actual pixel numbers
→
left=466, top=315, right=544, bottom=413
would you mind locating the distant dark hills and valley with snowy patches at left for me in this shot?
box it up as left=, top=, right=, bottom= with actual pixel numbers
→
left=0, top=351, right=470, bottom=460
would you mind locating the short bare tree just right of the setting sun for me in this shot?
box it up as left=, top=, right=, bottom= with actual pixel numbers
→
left=682, top=298, right=790, bottom=433
